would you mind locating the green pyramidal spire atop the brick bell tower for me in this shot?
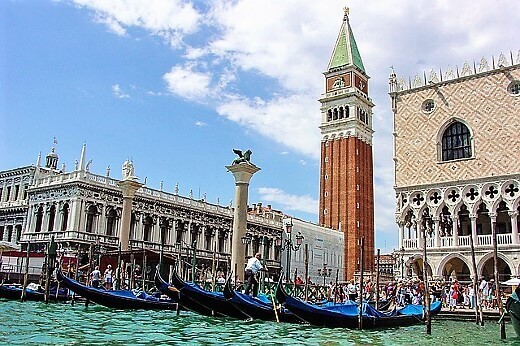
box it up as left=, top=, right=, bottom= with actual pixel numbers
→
left=328, top=8, right=366, bottom=73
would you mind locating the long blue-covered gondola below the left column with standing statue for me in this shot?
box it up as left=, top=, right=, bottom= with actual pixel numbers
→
left=56, top=270, right=177, bottom=310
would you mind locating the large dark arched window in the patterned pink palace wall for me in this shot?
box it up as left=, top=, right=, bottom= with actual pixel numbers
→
left=442, top=121, right=472, bottom=161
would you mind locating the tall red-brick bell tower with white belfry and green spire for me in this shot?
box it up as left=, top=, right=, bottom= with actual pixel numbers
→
left=319, top=8, right=374, bottom=279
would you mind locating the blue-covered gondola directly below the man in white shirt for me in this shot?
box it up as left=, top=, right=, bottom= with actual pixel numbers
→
left=224, top=276, right=302, bottom=323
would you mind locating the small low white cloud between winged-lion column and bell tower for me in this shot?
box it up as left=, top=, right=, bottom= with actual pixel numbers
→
left=258, top=187, right=318, bottom=214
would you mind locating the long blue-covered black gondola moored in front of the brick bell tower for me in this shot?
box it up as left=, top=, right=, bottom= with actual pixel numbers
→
left=276, top=282, right=440, bottom=329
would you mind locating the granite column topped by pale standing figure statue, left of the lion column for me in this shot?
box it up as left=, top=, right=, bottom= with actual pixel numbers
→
left=119, top=161, right=144, bottom=251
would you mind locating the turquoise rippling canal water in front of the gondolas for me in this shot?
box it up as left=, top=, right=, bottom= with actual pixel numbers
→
left=0, top=300, right=520, bottom=346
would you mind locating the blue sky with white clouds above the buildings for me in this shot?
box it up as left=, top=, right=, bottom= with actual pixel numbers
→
left=0, top=0, right=520, bottom=253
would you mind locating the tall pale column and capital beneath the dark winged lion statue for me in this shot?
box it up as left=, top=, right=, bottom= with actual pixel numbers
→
left=226, top=162, right=260, bottom=281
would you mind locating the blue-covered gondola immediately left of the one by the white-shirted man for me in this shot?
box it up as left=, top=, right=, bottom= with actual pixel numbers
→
left=167, top=270, right=251, bottom=319
